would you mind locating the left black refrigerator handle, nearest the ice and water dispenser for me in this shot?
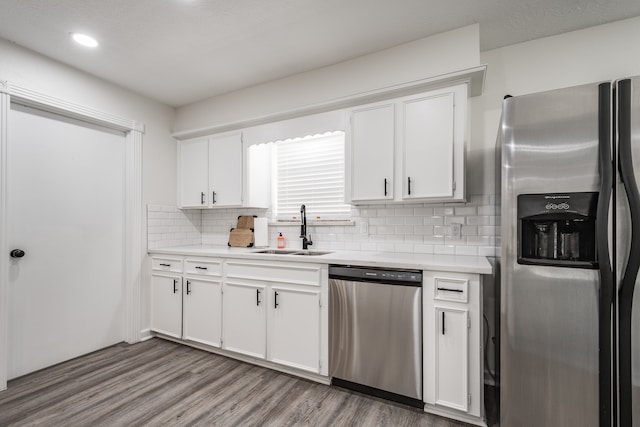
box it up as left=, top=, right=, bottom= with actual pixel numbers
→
left=596, top=83, right=614, bottom=427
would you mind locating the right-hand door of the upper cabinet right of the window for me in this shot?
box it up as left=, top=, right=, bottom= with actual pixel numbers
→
left=402, top=92, right=454, bottom=199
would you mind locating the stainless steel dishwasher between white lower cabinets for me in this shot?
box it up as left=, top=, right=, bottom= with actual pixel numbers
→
left=329, top=266, right=424, bottom=408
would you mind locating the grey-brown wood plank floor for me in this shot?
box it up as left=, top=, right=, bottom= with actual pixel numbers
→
left=0, top=338, right=478, bottom=427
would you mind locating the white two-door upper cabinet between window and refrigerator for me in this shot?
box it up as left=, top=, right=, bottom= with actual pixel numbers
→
left=350, top=84, right=467, bottom=204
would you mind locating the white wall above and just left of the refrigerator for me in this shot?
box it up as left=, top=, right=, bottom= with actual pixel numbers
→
left=468, top=17, right=640, bottom=199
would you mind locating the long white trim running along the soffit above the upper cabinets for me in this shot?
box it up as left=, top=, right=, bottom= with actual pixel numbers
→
left=172, top=65, right=487, bottom=140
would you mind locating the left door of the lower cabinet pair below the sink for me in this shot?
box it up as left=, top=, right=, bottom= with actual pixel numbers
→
left=222, top=283, right=267, bottom=359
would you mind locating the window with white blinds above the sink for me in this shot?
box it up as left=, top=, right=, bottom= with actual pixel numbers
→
left=273, top=131, right=351, bottom=221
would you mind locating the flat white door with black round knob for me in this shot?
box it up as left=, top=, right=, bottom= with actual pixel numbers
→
left=4, top=105, right=126, bottom=379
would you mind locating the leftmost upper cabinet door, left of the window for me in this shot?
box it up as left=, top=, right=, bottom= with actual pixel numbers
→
left=178, top=138, right=209, bottom=208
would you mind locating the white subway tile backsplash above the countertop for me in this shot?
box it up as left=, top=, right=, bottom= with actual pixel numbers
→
left=147, top=195, right=500, bottom=256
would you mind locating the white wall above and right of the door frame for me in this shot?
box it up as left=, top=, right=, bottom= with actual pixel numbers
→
left=0, top=39, right=176, bottom=329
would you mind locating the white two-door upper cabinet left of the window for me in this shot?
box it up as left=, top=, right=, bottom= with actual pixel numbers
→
left=178, top=132, right=269, bottom=209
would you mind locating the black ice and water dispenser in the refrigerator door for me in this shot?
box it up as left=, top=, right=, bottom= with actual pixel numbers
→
left=518, top=192, right=598, bottom=268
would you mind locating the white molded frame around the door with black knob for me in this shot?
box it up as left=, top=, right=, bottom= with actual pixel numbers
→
left=0, top=80, right=144, bottom=391
